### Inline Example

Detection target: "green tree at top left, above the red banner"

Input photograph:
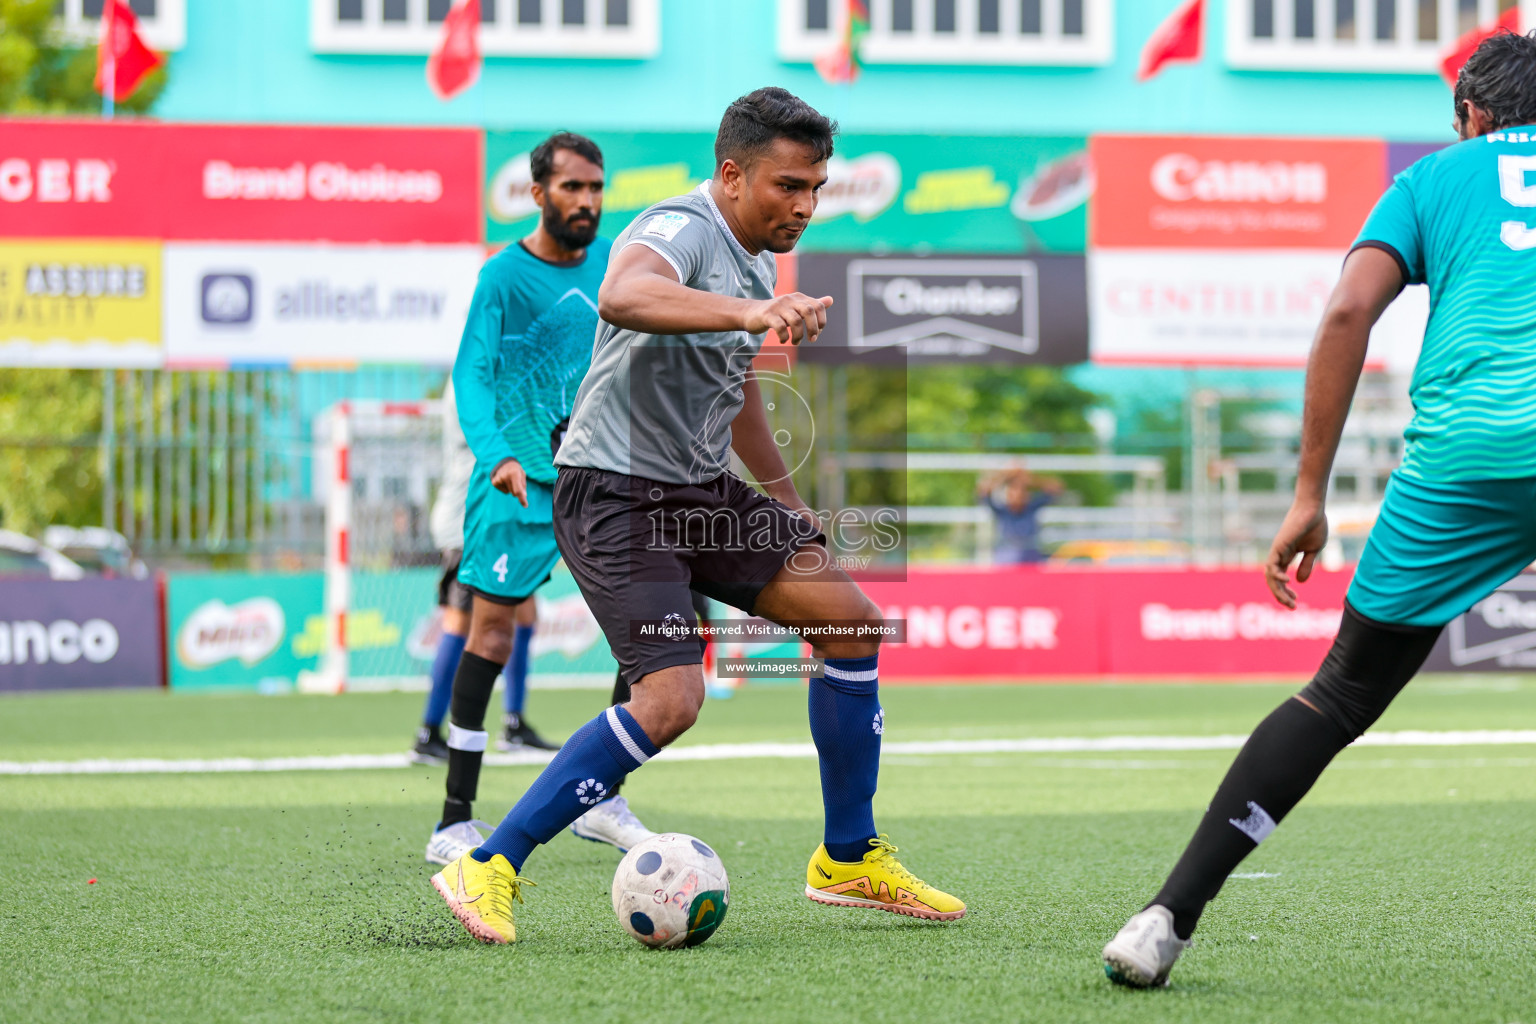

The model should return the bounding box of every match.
[0,0,166,114]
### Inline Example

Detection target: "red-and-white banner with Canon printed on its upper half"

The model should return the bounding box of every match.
[1087,135,1428,363]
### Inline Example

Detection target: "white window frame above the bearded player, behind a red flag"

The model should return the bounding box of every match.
[309,0,662,58]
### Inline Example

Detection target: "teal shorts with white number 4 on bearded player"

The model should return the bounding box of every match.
[459,470,561,605]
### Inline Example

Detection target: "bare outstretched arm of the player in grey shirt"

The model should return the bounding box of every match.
[598,244,833,344]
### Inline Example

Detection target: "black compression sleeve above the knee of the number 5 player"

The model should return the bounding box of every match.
[1301,602,1444,740]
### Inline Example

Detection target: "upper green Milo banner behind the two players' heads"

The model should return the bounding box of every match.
[485,132,1094,253]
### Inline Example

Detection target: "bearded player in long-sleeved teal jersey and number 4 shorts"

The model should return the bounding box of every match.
[427,132,651,864]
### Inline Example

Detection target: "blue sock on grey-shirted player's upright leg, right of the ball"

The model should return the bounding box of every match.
[811,656,885,863]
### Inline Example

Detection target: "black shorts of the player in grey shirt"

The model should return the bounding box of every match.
[554,467,826,683]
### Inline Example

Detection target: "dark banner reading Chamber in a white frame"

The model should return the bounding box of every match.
[797,253,1087,365]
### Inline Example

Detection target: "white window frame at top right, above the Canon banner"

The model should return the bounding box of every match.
[1226,0,1536,75]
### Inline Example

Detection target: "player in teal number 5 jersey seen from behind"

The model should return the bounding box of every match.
[1104,32,1536,987]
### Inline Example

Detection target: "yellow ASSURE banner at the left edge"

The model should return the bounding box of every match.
[0,241,161,367]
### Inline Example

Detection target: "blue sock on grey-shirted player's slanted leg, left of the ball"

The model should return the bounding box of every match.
[473,708,659,870]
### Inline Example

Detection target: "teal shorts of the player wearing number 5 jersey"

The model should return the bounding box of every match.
[1349,473,1536,626]
